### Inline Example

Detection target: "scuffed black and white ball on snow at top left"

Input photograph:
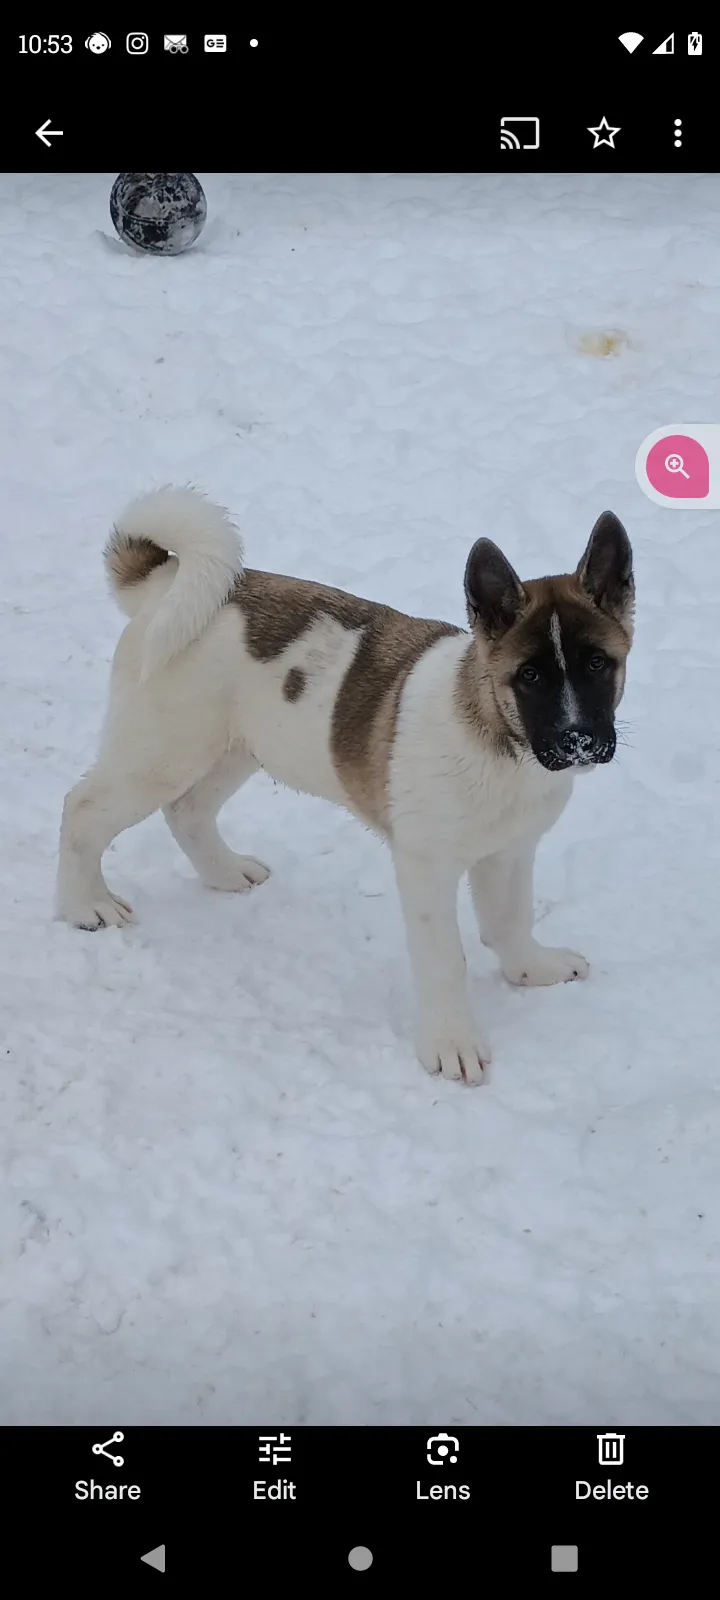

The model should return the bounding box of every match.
[110,173,208,256]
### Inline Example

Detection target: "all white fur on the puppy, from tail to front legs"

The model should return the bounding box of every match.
[58,491,587,1083]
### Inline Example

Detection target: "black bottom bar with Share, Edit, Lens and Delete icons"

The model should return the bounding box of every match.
[5,1419,714,1594]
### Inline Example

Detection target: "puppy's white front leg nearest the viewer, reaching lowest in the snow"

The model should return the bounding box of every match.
[394,850,490,1083]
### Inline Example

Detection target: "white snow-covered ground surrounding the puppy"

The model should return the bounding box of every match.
[0,174,720,1427]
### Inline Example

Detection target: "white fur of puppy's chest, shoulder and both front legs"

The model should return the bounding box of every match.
[382,637,587,1083]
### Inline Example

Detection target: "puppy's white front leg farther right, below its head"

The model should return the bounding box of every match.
[469,840,589,987]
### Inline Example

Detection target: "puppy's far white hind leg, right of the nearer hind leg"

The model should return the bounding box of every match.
[163,744,269,894]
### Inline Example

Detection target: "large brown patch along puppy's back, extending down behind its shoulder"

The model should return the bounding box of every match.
[232,568,462,832]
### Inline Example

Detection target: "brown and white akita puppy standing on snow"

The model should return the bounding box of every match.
[58,488,634,1083]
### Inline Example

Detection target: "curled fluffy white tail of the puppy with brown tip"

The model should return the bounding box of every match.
[104,488,243,678]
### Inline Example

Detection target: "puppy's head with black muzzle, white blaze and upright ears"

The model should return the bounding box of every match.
[466,510,635,771]
